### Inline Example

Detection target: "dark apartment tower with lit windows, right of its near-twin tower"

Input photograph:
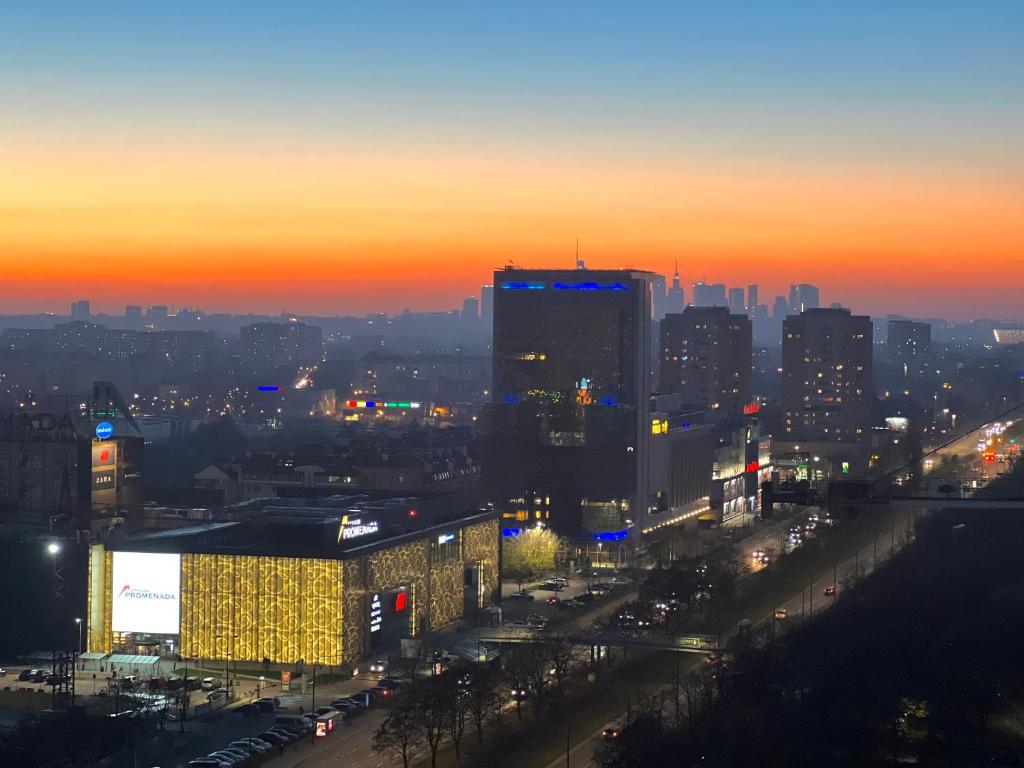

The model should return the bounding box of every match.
[782,309,874,442]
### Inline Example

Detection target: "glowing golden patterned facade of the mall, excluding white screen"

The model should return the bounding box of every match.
[88,519,500,666]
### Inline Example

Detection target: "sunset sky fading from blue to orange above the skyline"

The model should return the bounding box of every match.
[0,0,1024,318]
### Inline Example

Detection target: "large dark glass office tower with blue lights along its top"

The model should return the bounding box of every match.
[483,269,652,546]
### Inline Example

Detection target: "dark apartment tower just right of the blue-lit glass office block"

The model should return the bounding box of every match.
[658,306,753,417]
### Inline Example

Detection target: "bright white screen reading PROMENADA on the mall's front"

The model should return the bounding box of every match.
[111,552,181,635]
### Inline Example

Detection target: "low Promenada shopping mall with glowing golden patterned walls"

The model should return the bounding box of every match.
[88,497,501,665]
